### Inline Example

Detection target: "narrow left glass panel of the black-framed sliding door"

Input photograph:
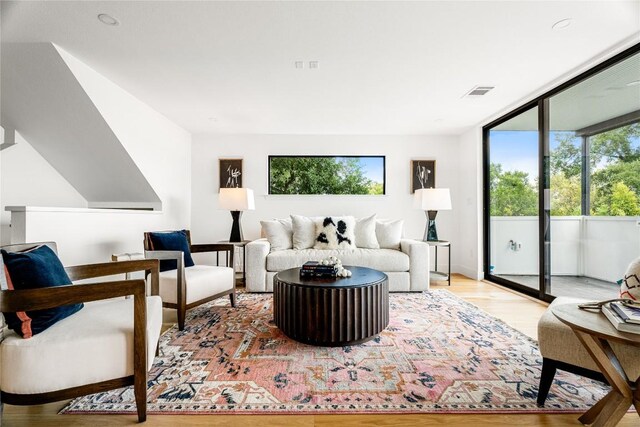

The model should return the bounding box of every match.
[487,107,540,298]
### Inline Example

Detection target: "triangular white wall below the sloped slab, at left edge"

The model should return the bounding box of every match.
[0,134,87,245]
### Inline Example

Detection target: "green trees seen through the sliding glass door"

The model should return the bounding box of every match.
[490,123,640,216]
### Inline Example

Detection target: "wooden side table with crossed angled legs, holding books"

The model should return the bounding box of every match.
[552,304,640,427]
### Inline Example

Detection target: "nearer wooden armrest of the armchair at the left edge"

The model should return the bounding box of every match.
[0,279,146,313]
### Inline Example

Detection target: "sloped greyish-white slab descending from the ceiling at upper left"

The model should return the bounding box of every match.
[0,43,161,208]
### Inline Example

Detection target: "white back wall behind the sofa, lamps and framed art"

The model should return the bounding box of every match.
[191,135,461,268]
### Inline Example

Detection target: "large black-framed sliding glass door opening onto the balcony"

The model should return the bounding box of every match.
[484,45,640,300]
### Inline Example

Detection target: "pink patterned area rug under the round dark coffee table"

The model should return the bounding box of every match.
[61,290,608,414]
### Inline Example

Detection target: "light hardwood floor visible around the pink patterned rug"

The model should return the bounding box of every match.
[2,275,640,427]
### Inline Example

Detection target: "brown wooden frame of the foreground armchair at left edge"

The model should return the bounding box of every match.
[0,242,159,422]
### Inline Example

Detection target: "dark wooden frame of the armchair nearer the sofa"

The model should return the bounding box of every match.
[144,230,236,331]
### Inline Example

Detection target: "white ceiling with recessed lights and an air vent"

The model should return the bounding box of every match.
[1,1,640,134]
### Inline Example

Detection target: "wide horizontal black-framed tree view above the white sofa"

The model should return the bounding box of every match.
[269,156,385,195]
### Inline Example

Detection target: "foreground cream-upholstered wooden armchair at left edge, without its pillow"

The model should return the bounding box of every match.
[0,242,162,422]
